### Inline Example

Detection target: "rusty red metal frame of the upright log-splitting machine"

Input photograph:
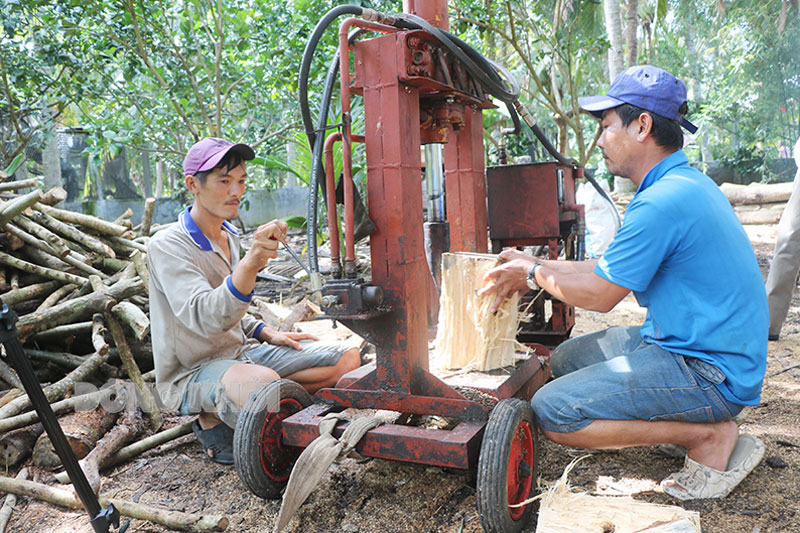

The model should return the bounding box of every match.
[282,0,549,469]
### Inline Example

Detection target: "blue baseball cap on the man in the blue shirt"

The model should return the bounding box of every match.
[578,65,697,133]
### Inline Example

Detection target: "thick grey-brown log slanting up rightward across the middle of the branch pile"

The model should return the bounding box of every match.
[17,278,144,338]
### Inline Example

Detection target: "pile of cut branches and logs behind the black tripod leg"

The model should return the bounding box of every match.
[0,180,227,532]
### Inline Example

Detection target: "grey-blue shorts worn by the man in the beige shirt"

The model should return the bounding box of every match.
[179,341,353,427]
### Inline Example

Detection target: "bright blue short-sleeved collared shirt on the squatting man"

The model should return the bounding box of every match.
[594,151,769,405]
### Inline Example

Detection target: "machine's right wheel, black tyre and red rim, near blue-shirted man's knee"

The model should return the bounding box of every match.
[477,398,539,533]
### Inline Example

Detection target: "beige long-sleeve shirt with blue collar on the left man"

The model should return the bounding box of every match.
[147,208,263,409]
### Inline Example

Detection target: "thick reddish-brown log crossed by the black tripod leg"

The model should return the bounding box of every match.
[33,407,119,470]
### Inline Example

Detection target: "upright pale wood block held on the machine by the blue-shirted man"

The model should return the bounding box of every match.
[431,253,520,370]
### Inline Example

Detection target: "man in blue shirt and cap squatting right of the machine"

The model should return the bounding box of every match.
[481,66,768,500]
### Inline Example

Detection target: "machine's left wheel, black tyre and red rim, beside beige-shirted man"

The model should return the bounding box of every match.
[233,379,312,499]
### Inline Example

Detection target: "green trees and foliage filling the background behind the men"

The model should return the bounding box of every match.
[0,0,800,195]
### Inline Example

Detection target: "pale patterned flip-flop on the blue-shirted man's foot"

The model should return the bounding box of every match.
[661,434,764,500]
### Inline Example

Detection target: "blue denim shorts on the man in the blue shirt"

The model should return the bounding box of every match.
[531,326,743,433]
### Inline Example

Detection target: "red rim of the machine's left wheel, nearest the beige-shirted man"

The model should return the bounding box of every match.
[258,398,303,481]
